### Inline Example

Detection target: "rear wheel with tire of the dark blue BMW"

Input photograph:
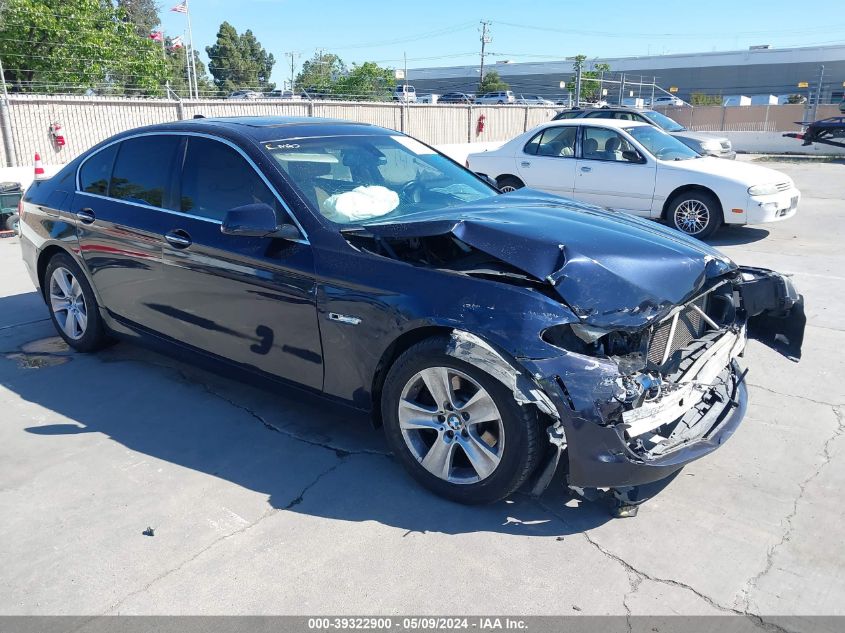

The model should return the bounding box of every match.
[41,253,110,352]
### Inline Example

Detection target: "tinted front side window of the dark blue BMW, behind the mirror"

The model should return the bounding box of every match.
[180,136,279,221]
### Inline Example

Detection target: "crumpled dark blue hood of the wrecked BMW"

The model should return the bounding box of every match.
[365,189,736,328]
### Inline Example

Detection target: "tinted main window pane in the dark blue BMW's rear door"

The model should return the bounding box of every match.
[109,135,180,208]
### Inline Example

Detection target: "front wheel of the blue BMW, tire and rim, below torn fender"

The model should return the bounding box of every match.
[381,337,541,504]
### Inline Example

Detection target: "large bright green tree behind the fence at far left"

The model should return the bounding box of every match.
[0,0,165,95]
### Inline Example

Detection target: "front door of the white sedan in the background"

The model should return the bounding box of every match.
[573,125,657,216]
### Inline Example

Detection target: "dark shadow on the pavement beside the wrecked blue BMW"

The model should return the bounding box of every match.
[0,298,611,537]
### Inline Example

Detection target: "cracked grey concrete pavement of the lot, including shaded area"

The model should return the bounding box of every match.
[0,158,845,616]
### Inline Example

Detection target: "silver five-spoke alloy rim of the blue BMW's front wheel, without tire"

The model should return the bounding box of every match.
[398,367,505,484]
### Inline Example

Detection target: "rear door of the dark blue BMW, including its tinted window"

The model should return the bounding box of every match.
[71,135,180,329]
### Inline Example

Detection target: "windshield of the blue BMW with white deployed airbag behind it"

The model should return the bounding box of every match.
[262,135,498,225]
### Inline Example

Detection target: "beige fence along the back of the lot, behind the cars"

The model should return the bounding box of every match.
[0,95,838,166]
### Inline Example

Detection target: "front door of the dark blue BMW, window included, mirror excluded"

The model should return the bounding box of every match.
[154,135,323,389]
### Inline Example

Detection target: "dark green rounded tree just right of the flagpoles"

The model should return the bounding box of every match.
[205,22,276,95]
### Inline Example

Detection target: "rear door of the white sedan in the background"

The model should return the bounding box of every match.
[516,125,578,197]
